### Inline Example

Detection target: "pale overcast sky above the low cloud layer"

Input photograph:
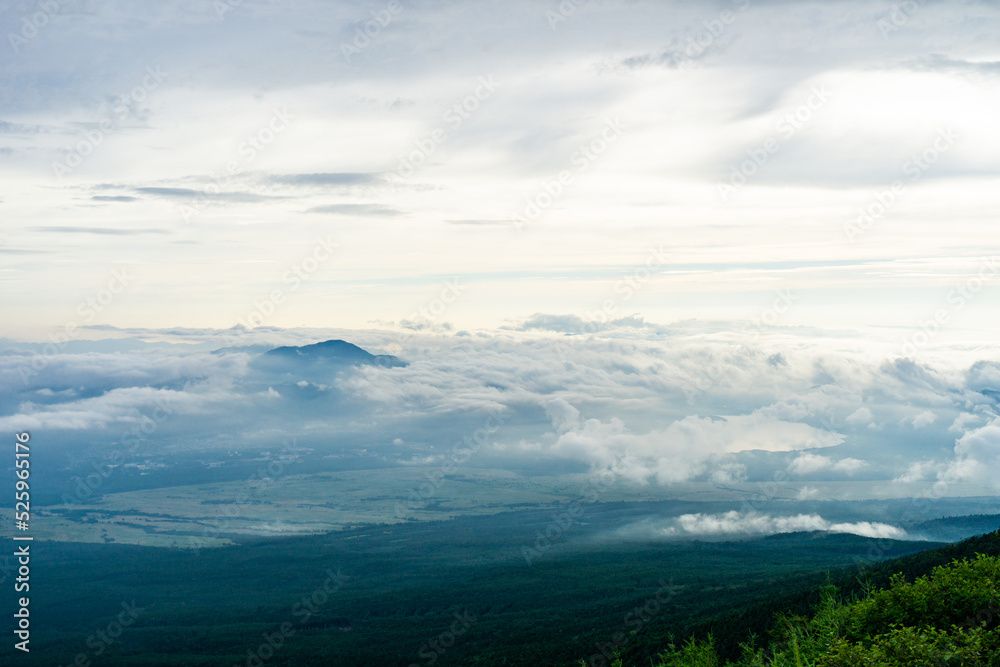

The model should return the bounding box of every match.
[0,0,1000,342]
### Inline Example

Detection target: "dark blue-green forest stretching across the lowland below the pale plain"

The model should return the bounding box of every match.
[0,506,1000,667]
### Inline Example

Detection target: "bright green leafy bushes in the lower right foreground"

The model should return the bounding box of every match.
[659,555,1000,667]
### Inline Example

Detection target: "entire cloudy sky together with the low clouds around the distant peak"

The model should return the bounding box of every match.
[0,0,1000,496]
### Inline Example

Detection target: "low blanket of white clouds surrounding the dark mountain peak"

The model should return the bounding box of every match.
[0,323,1000,497]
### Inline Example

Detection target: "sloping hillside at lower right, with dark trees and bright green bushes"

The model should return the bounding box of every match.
[648,532,1000,667]
